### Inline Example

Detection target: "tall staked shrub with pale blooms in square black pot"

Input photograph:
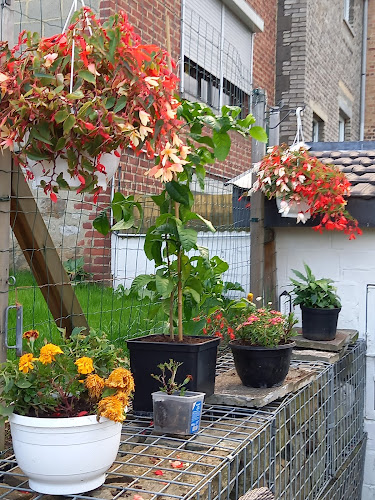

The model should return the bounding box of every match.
[107,101,266,413]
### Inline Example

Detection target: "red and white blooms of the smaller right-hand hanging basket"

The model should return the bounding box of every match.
[251,145,362,239]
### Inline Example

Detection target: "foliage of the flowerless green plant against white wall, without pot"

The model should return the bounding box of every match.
[290,263,341,309]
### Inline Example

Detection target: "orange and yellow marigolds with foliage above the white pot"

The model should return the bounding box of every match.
[0,328,134,422]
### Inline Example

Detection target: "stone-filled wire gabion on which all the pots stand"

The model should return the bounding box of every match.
[0,342,365,500]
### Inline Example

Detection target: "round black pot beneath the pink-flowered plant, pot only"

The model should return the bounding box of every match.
[229,340,295,388]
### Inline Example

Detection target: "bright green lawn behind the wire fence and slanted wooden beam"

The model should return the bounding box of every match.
[9,271,165,343]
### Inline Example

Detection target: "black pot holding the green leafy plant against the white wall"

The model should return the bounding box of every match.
[301,305,341,340]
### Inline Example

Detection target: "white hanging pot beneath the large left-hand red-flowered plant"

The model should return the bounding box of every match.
[27,148,120,189]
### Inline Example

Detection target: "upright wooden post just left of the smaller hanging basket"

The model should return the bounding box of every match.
[250,89,266,297]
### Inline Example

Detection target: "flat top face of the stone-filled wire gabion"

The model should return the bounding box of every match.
[0,405,272,500]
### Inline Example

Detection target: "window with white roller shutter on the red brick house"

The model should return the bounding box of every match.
[181,0,253,114]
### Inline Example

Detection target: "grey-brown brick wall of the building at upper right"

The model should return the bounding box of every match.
[276,0,363,143]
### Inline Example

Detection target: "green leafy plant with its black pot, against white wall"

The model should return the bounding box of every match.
[290,264,341,340]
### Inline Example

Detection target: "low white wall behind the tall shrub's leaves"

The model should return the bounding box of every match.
[112,231,250,293]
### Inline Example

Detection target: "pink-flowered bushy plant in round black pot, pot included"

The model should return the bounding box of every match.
[215,299,297,388]
